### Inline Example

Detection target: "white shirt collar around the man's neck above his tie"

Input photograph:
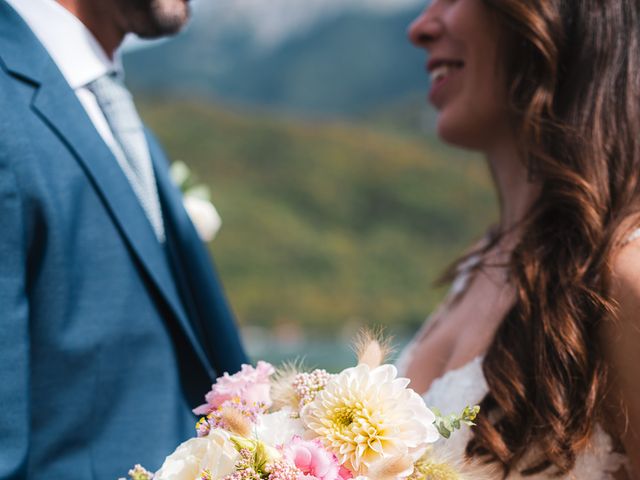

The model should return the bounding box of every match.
[6,0,122,90]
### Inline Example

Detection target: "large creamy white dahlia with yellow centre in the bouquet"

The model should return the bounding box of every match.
[301,364,439,478]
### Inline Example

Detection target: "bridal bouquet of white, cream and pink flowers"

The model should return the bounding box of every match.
[121,338,478,480]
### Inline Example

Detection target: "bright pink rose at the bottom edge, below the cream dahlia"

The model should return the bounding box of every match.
[282,436,351,480]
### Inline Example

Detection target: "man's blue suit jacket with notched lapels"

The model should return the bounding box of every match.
[0,0,245,480]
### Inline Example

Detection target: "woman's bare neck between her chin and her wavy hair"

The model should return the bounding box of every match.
[487,139,540,237]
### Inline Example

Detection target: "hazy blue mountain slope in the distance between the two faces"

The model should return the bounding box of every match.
[125,8,427,116]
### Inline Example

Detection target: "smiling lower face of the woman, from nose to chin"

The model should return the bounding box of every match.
[409,0,510,151]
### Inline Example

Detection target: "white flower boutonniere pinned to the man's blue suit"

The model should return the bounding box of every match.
[170,161,222,243]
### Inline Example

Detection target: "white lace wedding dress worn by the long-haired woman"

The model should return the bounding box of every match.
[396,229,640,480]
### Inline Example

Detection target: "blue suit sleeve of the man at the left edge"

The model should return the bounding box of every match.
[0,158,30,480]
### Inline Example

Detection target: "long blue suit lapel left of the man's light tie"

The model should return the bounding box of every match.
[0,0,214,376]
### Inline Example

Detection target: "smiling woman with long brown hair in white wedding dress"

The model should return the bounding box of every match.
[399,0,640,480]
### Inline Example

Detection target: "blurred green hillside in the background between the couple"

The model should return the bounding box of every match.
[141,102,496,334]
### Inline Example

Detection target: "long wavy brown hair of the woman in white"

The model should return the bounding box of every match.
[450,0,640,475]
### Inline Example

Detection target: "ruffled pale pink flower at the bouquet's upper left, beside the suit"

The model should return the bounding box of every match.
[193,361,275,415]
